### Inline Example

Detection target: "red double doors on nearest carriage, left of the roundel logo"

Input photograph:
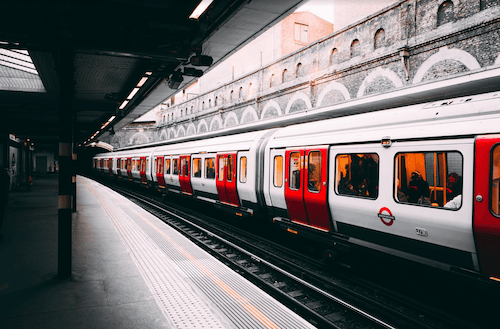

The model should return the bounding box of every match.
[285,146,331,231]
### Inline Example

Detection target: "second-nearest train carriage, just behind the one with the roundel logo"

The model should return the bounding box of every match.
[152,130,274,216]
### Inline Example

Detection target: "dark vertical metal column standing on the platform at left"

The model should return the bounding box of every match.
[57,47,75,278]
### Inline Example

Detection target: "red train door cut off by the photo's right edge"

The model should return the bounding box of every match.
[474,135,500,279]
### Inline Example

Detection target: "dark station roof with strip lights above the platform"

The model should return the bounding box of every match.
[0,0,305,148]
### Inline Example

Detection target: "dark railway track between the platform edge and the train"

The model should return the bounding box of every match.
[97,179,479,329]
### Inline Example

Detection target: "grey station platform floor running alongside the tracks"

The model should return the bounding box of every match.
[0,174,313,328]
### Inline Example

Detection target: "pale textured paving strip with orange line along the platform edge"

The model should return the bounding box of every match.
[79,177,314,329]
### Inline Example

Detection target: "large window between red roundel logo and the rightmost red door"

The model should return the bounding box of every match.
[394,152,463,209]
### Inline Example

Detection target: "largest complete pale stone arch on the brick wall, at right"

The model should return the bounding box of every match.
[413,47,481,84]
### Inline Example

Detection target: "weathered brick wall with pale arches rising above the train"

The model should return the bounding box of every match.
[103,0,500,145]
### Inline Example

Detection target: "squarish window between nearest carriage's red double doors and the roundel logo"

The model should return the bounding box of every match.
[335,153,379,199]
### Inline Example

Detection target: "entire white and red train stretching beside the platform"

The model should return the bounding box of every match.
[93,92,500,284]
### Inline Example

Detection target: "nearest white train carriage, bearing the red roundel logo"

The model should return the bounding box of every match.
[264,94,500,276]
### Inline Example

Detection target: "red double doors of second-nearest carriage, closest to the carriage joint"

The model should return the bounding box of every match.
[216,152,240,206]
